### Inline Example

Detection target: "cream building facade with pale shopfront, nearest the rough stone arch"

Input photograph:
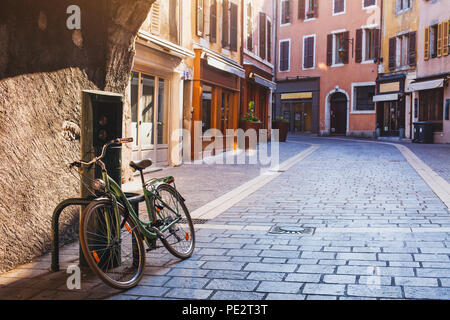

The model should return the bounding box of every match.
[128,0,194,167]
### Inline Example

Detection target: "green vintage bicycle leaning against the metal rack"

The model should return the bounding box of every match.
[69,138,195,289]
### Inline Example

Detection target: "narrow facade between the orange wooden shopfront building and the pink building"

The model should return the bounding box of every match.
[244,0,276,136]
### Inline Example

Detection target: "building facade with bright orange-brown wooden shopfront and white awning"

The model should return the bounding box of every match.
[183,0,245,159]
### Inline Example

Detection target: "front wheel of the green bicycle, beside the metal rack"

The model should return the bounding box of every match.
[80,199,145,290]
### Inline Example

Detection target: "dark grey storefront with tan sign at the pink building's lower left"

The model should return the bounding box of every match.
[274,78,320,134]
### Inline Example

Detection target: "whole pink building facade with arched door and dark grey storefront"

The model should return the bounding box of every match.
[275,0,381,137]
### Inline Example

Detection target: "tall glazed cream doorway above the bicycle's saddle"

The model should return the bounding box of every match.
[131,72,168,165]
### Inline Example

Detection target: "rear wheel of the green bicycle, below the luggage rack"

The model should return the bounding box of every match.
[152,184,195,259]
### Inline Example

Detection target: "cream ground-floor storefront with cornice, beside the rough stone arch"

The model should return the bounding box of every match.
[129,33,194,168]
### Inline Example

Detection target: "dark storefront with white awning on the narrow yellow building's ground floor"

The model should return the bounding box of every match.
[373,74,406,138]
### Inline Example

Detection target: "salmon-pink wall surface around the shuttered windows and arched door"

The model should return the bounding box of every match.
[276,0,381,133]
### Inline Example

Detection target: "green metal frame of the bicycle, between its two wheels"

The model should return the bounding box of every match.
[102,168,181,247]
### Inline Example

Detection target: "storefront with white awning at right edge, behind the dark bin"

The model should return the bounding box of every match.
[409,74,450,143]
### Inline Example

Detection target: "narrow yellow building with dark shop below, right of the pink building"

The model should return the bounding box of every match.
[374,0,420,139]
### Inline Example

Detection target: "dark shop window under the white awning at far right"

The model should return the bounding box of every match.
[419,88,444,132]
